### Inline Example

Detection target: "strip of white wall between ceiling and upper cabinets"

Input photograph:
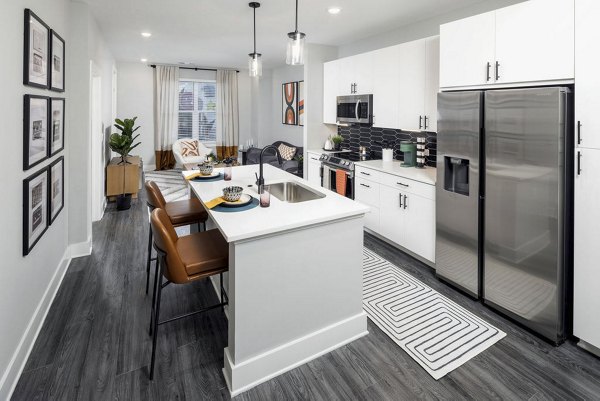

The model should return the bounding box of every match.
[338,0,524,58]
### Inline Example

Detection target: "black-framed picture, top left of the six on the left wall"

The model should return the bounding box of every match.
[23,8,50,88]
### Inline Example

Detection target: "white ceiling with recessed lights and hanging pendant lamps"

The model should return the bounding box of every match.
[85,0,483,68]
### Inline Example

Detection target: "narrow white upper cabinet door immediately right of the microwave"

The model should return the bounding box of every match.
[372,46,400,128]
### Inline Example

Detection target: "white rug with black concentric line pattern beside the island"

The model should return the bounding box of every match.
[363,248,506,380]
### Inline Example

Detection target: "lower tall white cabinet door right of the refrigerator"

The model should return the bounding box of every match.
[573,146,600,348]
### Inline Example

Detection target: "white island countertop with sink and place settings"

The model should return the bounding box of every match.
[182,164,369,242]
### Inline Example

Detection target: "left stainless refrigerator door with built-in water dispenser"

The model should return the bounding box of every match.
[435,92,483,297]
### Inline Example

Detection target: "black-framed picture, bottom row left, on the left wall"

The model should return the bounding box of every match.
[23,168,48,256]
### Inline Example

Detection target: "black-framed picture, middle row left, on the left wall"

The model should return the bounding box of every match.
[23,95,49,170]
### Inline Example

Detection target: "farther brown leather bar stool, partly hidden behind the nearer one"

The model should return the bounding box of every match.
[145,181,208,294]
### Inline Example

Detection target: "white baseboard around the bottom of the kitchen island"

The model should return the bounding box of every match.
[223,312,369,397]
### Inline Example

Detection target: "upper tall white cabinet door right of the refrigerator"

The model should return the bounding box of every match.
[575,0,600,149]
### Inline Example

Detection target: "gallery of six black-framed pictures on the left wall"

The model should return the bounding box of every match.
[23,9,65,256]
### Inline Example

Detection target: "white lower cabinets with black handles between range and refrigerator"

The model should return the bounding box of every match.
[355,167,435,262]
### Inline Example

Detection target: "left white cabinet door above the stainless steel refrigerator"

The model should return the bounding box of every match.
[440,11,496,87]
